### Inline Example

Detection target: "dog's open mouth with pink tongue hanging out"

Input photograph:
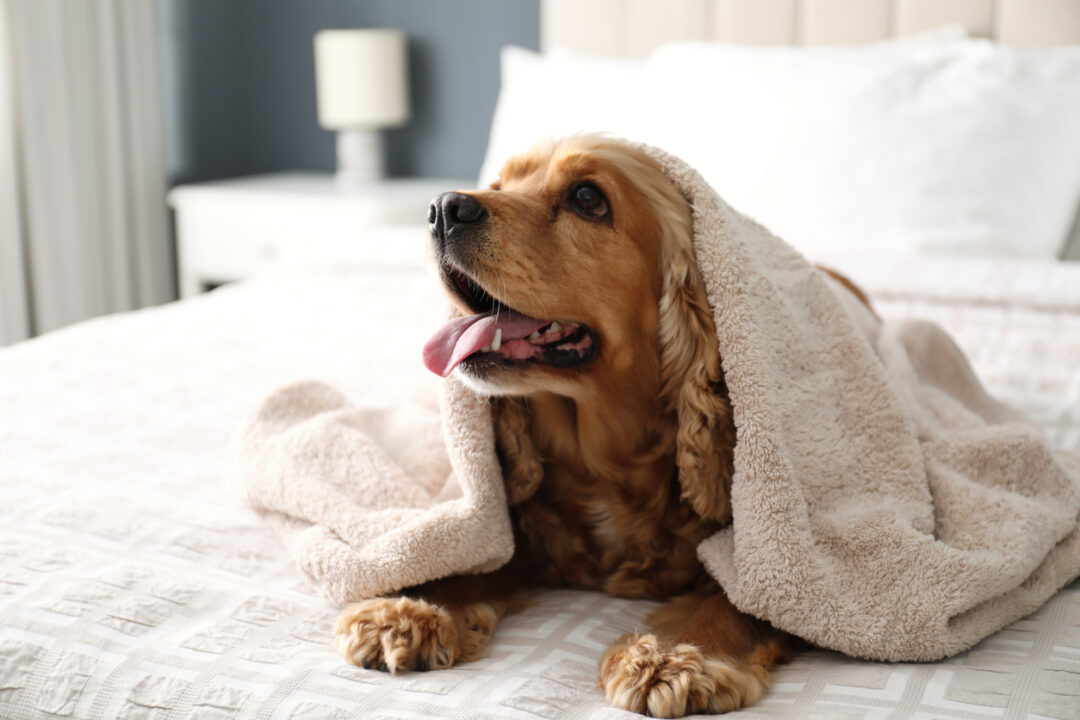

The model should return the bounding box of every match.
[423,266,597,378]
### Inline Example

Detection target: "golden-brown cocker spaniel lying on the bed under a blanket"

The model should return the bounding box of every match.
[335,136,865,718]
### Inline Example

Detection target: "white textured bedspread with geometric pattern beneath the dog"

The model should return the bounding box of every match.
[0,258,1080,720]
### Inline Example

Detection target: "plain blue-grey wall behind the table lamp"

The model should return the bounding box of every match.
[156,0,540,185]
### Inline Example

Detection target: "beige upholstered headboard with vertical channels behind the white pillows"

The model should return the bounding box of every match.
[541,0,1080,55]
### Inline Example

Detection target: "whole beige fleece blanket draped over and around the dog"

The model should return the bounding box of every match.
[229,143,1080,661]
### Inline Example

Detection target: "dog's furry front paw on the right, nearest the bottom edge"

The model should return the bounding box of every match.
[599,635,766,718]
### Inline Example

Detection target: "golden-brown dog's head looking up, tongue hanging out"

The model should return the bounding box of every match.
[426,136,715,405]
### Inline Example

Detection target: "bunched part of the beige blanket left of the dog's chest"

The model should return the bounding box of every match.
[226,381,513,604]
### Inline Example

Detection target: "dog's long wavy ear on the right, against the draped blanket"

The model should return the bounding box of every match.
[659,199,734,521]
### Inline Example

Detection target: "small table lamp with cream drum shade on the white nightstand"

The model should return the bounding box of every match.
[315,29,409,185]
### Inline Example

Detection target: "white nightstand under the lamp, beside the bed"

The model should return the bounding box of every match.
[168,173,475,298]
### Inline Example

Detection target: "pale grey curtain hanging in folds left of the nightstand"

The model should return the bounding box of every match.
[0,0,174,342]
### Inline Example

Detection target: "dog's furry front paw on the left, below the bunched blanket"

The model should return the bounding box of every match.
[334,598,459,673]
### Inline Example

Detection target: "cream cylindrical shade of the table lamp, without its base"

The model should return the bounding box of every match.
[315,29,409,130]
